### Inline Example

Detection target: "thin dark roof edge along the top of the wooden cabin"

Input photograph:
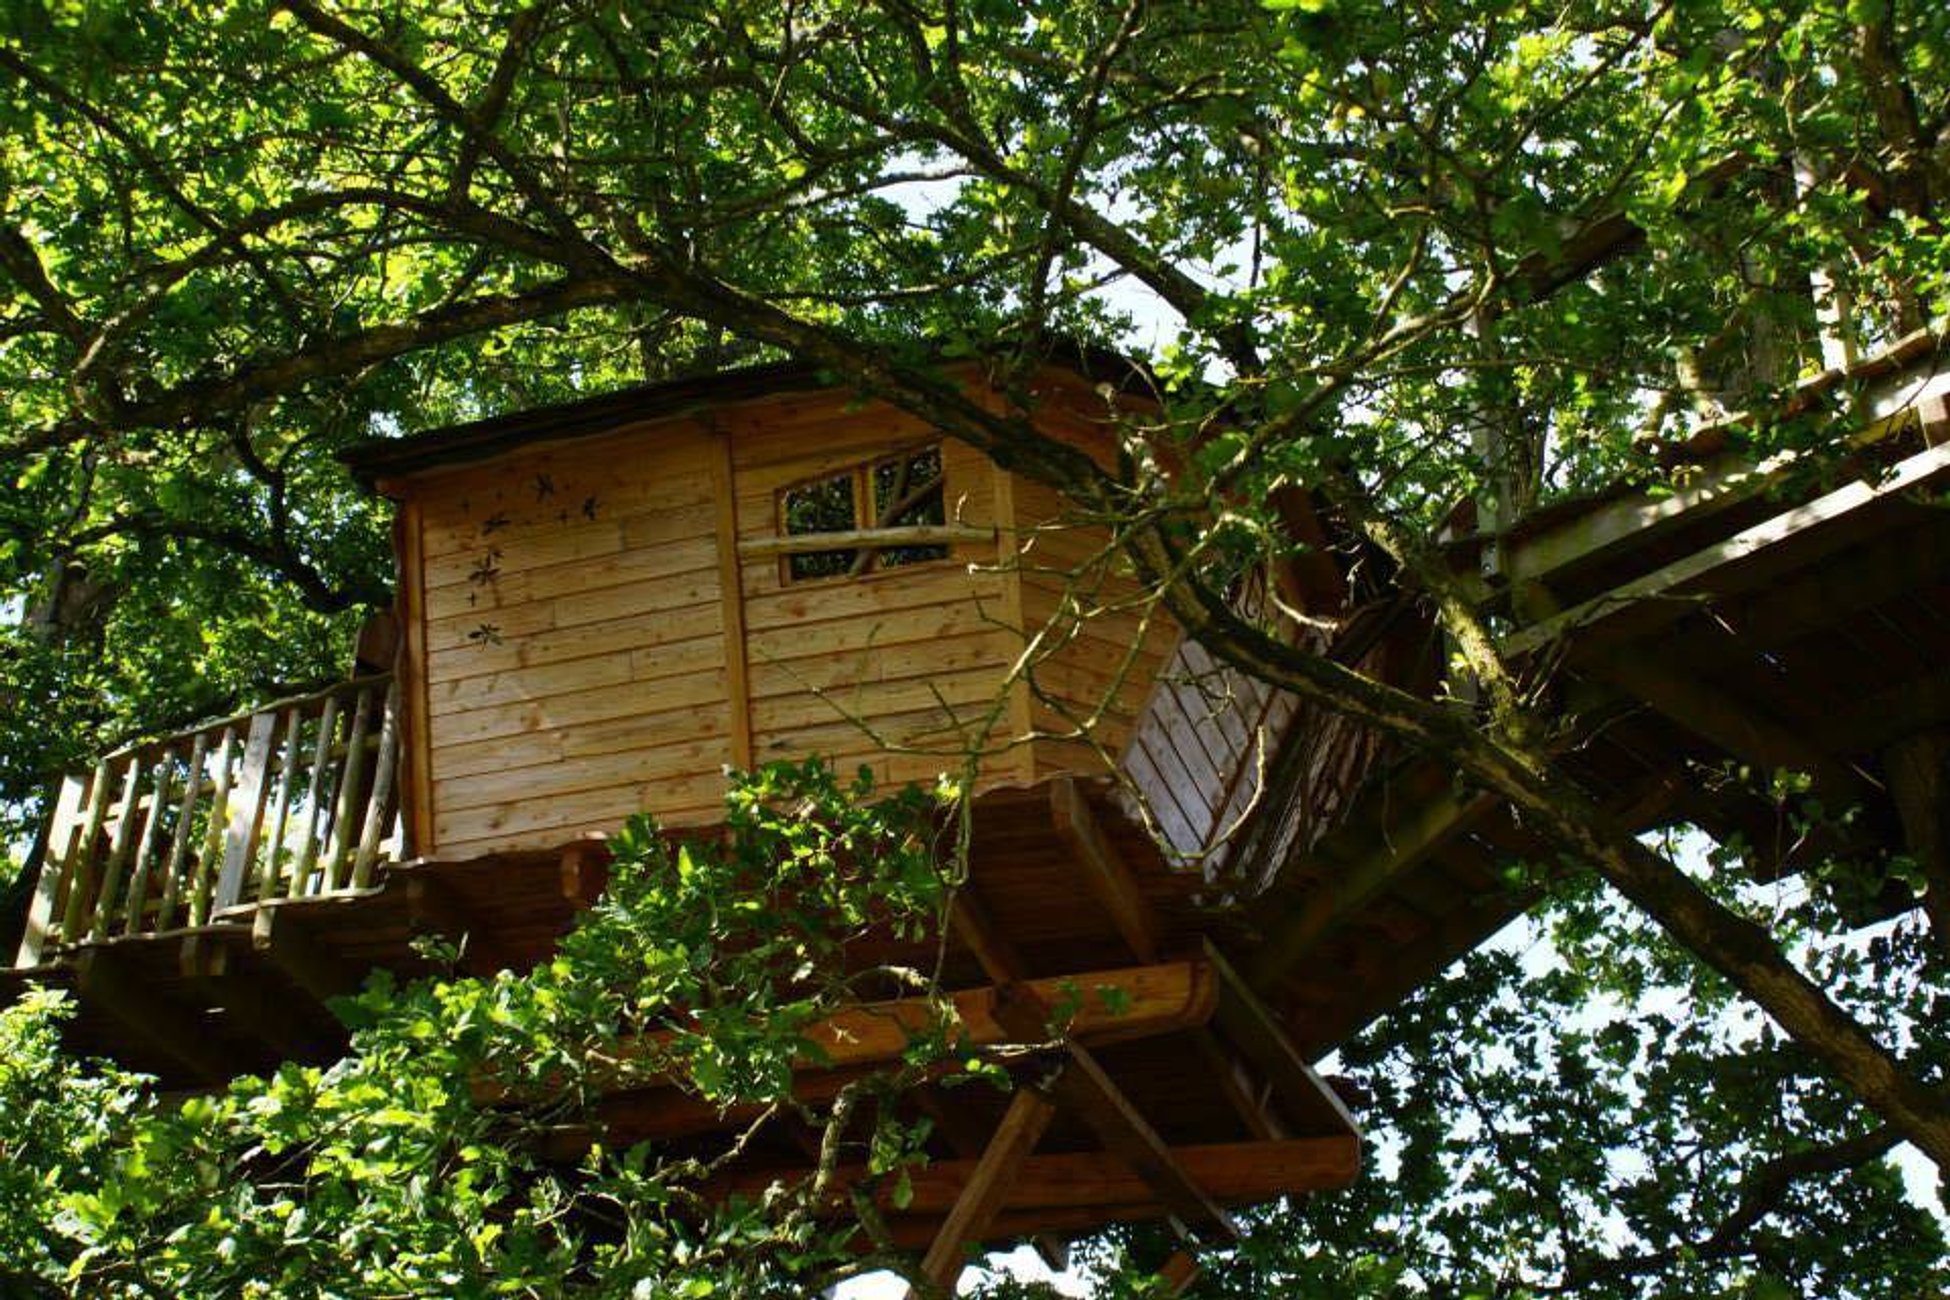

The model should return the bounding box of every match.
[339,341,1151,489]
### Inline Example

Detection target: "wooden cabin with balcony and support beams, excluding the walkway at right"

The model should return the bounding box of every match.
[3,352,1357,1281]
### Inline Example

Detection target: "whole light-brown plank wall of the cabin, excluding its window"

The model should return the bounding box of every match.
[402,374,1193,858]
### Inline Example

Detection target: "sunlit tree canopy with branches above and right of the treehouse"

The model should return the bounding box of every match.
[0,0,1950,1296]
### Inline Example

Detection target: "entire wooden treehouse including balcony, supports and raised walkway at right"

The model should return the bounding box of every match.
[12,335,1950,1281]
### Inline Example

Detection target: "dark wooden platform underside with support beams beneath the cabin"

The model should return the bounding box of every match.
[8,780,1359,1267]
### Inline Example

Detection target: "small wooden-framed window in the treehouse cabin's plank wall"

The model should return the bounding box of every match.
[778,446,948,583]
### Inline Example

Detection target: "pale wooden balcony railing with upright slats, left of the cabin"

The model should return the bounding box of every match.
[16,676,400,967]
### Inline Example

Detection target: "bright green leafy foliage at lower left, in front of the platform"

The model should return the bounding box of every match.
[0,764,982,1298]
